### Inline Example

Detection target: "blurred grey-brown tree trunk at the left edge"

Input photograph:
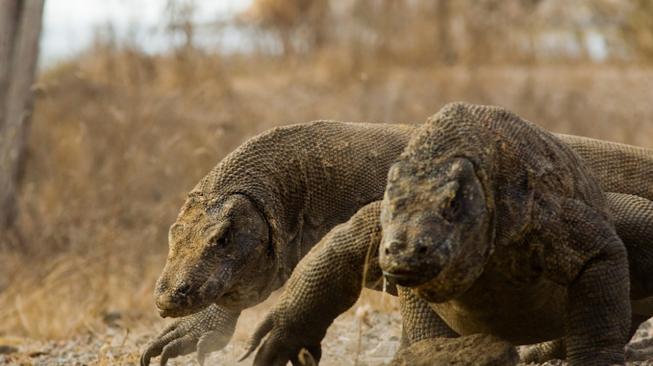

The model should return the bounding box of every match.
[0,0,44,241]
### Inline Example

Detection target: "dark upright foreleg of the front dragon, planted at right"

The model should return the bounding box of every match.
[543,200,631,366]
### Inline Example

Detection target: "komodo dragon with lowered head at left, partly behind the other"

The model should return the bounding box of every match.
[141,121,653,365]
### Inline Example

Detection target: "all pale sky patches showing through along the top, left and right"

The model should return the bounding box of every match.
[40,0,607,67]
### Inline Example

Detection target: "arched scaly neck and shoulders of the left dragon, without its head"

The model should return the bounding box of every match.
[189,121,413,286]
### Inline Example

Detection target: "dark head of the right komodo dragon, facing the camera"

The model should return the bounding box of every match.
[379,157,494,302]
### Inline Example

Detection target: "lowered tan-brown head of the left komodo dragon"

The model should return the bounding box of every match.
[154,194,273,317]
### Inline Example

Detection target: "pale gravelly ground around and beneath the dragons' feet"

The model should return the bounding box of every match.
[0,304,653,366]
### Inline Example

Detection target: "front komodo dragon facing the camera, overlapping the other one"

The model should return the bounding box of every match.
[243,104,653,365]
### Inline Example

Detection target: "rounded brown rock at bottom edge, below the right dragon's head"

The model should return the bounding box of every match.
[390,334,519,366]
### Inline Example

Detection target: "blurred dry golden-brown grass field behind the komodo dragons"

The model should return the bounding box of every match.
[0,43,653,339]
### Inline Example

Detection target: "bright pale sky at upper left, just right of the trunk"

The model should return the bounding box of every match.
[39,0,251,65]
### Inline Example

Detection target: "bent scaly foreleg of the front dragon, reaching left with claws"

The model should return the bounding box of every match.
[238,201,382,366]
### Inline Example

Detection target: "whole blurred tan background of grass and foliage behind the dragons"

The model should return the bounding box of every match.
[0,0,653,338]
